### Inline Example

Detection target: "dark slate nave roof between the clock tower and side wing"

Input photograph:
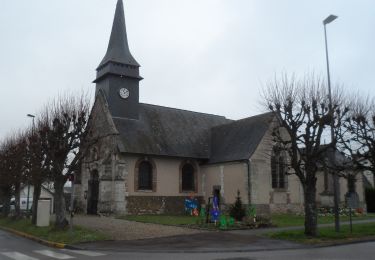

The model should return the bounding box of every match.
[113,104,231,159]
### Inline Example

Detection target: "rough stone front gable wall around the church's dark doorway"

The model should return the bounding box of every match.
[76,94,127,214]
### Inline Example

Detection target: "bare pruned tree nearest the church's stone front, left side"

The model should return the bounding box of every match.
[40,95,90,228]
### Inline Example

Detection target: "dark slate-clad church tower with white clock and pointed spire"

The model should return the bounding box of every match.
[94,0,142,119]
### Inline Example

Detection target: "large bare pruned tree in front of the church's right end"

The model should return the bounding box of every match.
[263,75,347,236]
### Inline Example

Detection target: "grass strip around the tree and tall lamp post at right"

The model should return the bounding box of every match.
[267,223,375,244]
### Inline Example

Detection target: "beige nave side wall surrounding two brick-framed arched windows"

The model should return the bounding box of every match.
[122,155,203,214]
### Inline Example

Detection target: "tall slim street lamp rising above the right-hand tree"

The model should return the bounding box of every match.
[323,14,340,232]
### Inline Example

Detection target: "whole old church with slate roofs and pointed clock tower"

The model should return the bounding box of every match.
[75,0,363,214]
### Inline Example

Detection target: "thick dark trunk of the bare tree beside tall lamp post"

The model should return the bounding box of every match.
[304,182,318,237]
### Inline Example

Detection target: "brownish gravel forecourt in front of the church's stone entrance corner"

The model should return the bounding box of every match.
[74,215,202,240]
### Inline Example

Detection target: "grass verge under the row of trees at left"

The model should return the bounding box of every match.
[0,218,109,244]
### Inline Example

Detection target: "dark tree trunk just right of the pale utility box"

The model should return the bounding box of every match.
[54,178,68,229]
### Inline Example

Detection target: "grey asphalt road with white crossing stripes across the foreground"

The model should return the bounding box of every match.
[0,231,375,260]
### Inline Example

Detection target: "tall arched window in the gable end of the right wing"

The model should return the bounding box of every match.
[271,147,287,189]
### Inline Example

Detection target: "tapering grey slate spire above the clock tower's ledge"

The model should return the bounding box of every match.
[98,0,140,68]
